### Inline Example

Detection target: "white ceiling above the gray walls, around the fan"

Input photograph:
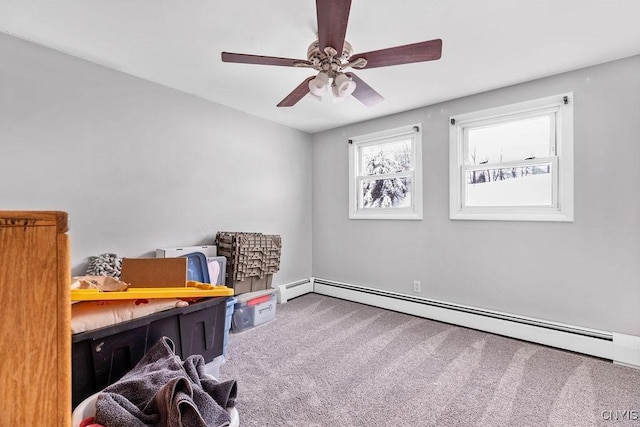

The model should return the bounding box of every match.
[0,0,640,133]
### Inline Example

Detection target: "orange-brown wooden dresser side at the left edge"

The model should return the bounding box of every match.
[0,211,71,427]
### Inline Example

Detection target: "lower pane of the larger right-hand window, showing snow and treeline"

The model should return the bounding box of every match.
[465,163,553,206]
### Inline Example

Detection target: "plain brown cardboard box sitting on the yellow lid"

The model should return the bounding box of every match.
[120,257,188,288]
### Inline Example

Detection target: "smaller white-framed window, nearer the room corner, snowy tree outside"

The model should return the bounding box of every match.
[349,125,422,219]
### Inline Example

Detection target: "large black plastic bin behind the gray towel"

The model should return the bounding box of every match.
[71,298,227,408]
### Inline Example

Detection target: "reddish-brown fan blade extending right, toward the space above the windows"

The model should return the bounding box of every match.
[349,39,442,69]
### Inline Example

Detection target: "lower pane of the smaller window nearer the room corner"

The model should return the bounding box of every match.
[360,177,411,208]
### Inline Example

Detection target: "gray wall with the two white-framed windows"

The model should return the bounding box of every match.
[313,56,640,335]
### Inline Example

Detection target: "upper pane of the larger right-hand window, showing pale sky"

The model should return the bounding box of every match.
[467,115,552,165]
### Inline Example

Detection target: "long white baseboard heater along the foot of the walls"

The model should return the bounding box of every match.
[302,277,640,367]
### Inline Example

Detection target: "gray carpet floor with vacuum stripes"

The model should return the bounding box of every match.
[220,294,640,427]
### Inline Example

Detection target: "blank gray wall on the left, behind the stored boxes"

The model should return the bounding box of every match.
[0,34,311,284]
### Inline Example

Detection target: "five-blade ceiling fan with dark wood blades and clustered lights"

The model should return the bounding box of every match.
[222,0,442,107]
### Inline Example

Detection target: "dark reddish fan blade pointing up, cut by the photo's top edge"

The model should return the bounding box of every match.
[316,0,351,56]
